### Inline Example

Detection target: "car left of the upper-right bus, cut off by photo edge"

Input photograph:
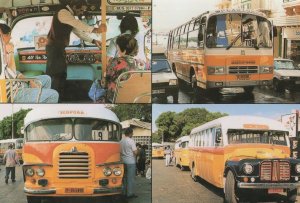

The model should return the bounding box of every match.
[151,54,179,103]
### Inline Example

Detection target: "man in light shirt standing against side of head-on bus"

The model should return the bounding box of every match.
[120,127,137,198]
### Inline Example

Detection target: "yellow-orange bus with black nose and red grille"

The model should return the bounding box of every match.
[189,116,300,203]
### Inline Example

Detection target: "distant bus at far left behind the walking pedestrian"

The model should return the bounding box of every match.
[0,138,24,164]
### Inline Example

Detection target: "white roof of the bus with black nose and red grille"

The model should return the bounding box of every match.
[191,116,288,134]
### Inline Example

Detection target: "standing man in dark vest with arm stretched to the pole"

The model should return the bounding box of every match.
[46,0,107,100]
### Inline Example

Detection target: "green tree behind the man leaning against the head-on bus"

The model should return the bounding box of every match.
[110,104,152,122]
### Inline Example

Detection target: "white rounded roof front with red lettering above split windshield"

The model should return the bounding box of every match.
[24,104,120,128]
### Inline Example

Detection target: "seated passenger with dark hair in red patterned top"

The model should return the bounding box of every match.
[104,34,145,102]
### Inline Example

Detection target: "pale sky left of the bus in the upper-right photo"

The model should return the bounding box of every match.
[152,0,221,33]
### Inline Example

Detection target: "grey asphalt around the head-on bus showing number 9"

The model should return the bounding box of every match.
[0,165,151,203]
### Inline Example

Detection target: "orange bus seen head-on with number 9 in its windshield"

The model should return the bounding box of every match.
[23,105,124,203]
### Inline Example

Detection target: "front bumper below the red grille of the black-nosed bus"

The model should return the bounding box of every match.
[237,182,300,189]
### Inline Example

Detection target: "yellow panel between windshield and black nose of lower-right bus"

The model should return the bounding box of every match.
[225,144,290,161]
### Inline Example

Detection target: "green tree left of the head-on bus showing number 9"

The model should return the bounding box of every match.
[0,109,31,139]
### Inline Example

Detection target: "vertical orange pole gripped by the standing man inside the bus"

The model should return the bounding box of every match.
[100,0,107,79]
